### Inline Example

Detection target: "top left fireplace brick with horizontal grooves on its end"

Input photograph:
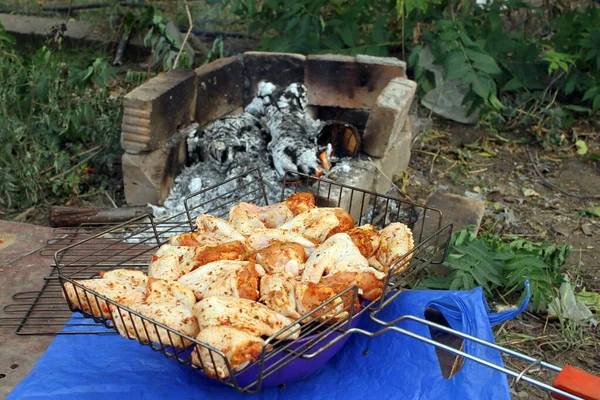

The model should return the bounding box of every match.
[121,69,196,154]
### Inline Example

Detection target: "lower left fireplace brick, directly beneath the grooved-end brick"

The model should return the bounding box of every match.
[122,137,186,205]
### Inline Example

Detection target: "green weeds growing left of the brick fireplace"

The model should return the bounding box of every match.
[0,25,121,208]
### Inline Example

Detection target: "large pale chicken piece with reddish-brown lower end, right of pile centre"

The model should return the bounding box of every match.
[302,233,386,300]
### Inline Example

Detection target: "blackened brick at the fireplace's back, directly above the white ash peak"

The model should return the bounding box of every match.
[243,51,306,103]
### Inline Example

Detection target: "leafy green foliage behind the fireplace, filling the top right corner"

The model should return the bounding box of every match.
[204,0,600,146]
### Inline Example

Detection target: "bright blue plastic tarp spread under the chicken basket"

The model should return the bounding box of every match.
[8,288,528,400]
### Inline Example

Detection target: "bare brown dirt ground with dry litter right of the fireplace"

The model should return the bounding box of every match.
[408,121,600,399]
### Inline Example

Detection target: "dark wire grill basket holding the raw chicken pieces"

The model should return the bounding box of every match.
[55,170,452,393]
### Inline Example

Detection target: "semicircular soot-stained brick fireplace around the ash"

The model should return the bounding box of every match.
[121,52,416,205]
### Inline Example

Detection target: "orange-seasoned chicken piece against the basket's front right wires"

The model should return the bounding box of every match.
[260,274,348,323]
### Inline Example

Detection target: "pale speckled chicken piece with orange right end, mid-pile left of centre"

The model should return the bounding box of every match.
[178,260,265,301]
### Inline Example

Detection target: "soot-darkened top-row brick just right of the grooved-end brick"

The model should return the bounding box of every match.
[196,57,244,126]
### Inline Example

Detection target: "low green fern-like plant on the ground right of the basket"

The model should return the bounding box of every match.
[419,229,572,310]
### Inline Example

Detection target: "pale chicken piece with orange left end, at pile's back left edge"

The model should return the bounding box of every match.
[169,214,246,246]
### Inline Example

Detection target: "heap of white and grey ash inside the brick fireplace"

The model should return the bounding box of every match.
[151,82,324,219]
